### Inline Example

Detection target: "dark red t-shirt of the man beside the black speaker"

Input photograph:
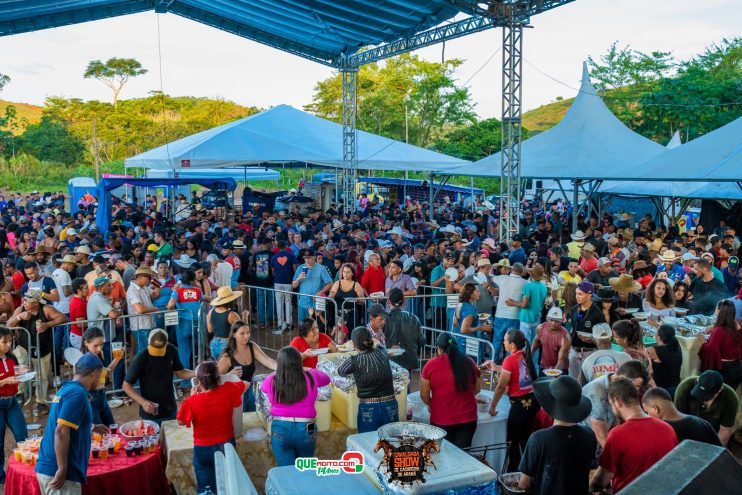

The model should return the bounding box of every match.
[600,417,678,493]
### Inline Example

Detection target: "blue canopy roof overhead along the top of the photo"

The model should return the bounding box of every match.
[0,0,459,64]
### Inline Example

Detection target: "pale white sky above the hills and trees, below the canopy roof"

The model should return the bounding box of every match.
[0,0,742,118]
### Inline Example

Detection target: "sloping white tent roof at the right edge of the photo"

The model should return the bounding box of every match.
[636,117,742,182]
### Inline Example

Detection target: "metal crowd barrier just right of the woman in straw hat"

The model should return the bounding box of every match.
[238,285,342,352]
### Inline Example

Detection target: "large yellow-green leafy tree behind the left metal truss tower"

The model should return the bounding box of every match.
[304,54,476,146]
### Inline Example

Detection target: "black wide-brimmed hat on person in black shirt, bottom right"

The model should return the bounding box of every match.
[533,375,593,423]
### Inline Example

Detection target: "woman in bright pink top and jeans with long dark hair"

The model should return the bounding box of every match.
[260,346,330,466]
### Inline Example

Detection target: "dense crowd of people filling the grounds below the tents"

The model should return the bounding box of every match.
[0,188,742,494]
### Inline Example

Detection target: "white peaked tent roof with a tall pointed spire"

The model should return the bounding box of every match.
[442,64,665,180]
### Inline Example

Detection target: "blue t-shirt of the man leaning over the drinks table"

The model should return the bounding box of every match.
[36,381,93,483]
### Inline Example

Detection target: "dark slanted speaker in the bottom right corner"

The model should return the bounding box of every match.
[621,440,742,495]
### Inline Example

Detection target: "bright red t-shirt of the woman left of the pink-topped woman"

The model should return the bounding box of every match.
[177,382,245,447]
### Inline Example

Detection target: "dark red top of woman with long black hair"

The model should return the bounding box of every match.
[422,354,480,425]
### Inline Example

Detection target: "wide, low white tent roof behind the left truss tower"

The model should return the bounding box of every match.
[126,105,471,172]
